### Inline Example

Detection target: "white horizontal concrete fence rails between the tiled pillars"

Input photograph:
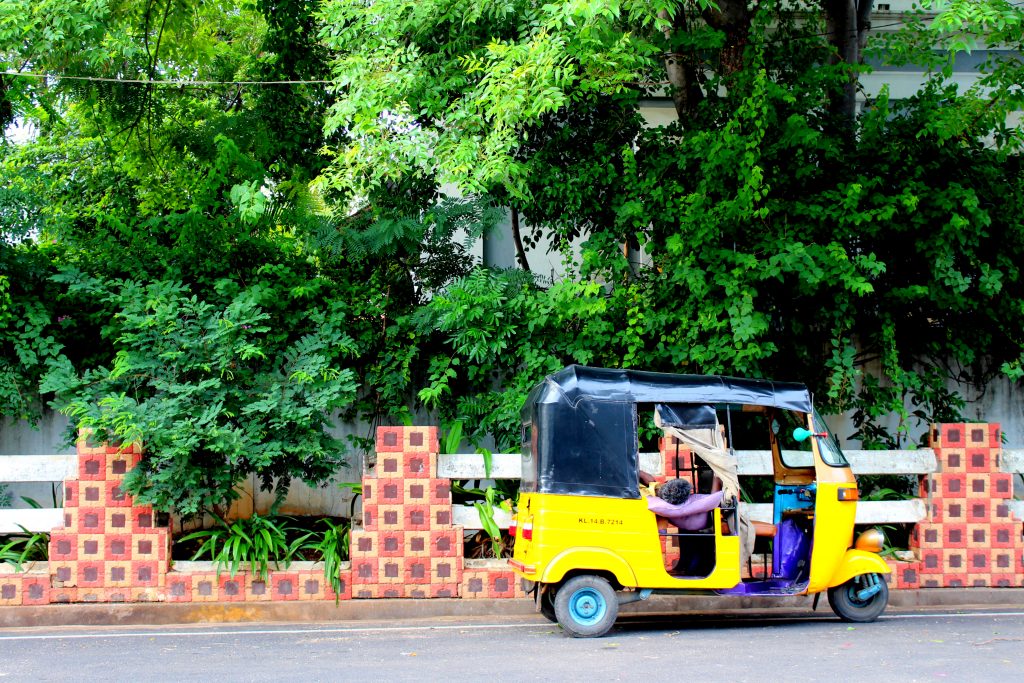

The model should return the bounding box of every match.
[0,449,1024,533]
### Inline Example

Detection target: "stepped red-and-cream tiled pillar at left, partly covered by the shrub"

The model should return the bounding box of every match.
[49,432,170,602]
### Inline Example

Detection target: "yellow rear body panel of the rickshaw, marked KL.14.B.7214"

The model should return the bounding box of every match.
[513,494,739,590]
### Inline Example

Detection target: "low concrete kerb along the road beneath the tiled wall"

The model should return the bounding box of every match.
[0,588,1024,628]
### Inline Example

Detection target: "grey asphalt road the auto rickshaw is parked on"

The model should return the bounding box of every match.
[0,607,1024,683]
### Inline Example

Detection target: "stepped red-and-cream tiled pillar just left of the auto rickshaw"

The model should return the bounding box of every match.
[349,427,463,598]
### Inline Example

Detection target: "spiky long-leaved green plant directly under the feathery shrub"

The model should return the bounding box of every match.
[178,513,309,582]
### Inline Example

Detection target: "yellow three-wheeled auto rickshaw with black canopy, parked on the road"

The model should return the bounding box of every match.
[510,366,890,637]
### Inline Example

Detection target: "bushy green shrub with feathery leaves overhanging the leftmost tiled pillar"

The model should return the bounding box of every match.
[43,274,356,516]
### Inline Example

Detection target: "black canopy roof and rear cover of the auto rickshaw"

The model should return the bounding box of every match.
[522,366,812,498]
